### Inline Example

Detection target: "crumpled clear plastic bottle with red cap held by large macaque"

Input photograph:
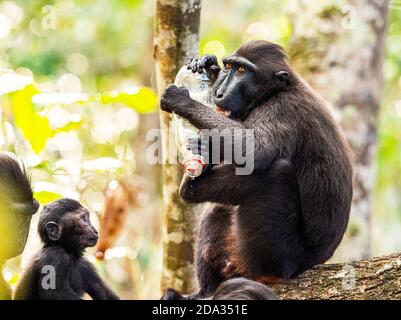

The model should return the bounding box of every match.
[173,66,213,178]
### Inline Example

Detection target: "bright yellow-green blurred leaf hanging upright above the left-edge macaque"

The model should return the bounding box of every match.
[11,85,54,153]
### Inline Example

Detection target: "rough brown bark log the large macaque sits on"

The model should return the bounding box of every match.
[269,253,401,300]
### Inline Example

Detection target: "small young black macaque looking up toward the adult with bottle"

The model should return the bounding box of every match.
[14,199,119,300]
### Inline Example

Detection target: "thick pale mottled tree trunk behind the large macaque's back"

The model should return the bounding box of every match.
[290,0,389,261]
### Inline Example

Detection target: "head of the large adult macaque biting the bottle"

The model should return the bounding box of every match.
[213,42,291,120]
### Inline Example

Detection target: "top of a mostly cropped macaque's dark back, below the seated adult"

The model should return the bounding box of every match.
[162,278,280,300]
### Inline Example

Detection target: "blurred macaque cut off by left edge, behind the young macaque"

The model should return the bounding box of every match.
[0,152,39,300]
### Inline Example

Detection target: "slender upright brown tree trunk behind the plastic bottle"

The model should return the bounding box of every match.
[154,0,201,293]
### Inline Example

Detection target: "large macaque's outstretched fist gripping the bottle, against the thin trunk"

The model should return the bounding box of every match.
[160,84,193,113]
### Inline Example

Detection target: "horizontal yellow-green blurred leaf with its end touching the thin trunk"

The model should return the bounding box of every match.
[100,87,157,113]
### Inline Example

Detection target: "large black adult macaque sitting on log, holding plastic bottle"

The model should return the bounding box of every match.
[160,41,352,297]
